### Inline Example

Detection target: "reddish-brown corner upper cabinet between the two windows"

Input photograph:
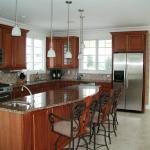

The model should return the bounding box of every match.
[46,36,79,68]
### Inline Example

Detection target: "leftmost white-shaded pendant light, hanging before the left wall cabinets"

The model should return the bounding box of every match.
[11,0,21,36]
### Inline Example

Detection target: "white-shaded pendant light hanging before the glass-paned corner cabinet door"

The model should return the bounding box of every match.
[65,1,72,59]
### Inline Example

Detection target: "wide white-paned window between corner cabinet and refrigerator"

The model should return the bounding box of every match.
[79,40,112,74]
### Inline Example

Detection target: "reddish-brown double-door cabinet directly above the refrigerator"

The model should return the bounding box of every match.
[111,31,147,52]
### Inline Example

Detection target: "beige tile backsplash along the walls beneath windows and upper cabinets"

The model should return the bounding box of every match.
[0,69,111,84]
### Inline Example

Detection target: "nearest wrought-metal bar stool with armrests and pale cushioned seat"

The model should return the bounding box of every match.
[49,102,85,150]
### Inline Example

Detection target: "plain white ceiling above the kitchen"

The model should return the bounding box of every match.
[0,0,150,31]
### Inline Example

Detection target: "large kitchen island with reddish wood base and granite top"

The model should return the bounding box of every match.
[0,84,101,150]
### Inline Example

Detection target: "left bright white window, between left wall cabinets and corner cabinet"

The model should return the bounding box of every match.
[26,38,45,71]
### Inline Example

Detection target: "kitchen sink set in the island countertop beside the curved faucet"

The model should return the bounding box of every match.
[2,101,31,109]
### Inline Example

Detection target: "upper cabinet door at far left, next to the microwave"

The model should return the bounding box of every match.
[0,28,12,69]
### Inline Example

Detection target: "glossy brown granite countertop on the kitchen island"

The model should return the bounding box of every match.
[0,84,99,114]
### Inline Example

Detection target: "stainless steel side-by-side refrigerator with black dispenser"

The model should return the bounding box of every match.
[113,53,144,111]
